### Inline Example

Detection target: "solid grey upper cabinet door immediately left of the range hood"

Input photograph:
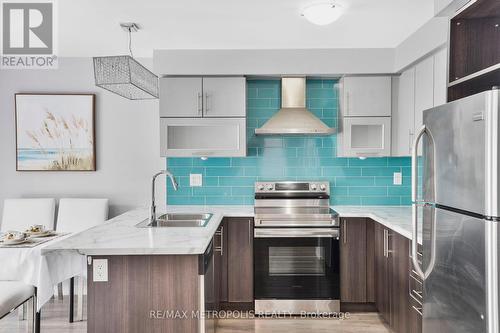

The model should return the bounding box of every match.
[203,77,246,117]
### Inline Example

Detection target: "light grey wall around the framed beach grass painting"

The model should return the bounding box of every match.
[0,58,165,218]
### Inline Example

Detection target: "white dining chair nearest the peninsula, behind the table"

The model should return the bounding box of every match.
[56,198,109,323]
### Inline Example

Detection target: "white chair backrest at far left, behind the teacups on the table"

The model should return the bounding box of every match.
[0,198,56,232]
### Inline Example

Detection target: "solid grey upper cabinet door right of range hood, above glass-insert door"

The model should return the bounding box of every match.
[341,76,391,117]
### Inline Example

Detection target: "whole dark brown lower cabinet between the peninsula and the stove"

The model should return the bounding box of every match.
[218,217,254,310]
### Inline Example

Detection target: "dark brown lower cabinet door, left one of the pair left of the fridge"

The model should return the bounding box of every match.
[374,223,391,323]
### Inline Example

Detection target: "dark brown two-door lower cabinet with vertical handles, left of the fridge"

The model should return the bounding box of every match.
[374,223,421,333]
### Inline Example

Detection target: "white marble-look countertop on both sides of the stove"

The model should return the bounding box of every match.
[44,202,418,255]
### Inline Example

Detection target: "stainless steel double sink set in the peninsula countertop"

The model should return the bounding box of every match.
[136,213,213,228]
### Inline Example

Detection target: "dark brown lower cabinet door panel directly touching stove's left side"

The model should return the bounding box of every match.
[226,218,253,303]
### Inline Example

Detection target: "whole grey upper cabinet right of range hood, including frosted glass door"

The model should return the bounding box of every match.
[337,76,392,157]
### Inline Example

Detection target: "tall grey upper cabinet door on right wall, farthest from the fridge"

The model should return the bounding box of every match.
[392,67,415,156]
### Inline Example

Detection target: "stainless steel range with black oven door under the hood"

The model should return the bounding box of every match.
[254,182,340,314]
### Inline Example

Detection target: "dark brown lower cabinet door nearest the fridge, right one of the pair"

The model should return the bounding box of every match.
[389,232,410,332]
